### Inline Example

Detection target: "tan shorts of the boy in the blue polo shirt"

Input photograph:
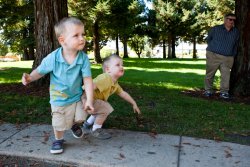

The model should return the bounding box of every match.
[51,101,88,131]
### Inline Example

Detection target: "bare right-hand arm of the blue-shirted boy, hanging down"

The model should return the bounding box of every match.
[83,77,94,112]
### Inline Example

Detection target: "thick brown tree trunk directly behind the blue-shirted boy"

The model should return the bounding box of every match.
[32,0,68,85]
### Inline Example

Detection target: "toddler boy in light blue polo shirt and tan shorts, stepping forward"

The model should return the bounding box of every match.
[22,17,93,154]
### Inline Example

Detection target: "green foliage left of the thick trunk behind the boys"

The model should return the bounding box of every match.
[0,0,35,54]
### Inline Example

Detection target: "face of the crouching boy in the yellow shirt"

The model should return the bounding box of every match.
[106,58,124,78]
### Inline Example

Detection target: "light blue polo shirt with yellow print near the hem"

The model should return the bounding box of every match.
[37,48,91,106]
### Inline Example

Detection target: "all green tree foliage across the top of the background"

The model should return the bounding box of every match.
[0,0,235,61]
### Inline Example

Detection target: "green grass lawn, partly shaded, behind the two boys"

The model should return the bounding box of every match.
[0,59,250,145]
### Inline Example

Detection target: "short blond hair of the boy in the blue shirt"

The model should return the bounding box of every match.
[54,17,84,38]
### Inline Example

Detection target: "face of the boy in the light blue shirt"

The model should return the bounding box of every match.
[59,24,85,51]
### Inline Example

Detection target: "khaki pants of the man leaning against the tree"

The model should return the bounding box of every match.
[205,51,234,93]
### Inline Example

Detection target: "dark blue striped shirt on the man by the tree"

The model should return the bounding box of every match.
[207,24,239,56]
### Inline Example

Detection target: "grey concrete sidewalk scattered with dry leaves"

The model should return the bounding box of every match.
[0,124,250,167]
